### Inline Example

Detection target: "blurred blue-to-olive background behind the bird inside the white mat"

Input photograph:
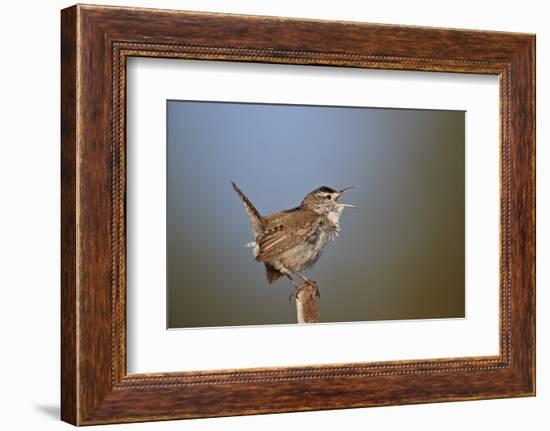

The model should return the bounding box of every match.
[166,101,465,328]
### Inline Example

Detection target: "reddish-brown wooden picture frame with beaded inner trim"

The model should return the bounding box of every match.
[61,5,535,425]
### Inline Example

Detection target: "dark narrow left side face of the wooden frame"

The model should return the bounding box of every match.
[60,6,79,425]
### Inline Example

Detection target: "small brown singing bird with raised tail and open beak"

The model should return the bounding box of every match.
[231,181,356,298]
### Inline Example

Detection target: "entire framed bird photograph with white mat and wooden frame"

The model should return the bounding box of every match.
[61,5,535,425]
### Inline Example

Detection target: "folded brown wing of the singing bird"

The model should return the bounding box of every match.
[256,211,321,262]
